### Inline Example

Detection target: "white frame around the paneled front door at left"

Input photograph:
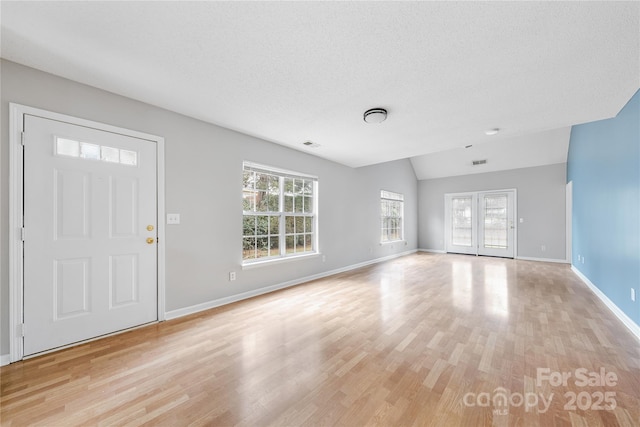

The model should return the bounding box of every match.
[9,103,165,363]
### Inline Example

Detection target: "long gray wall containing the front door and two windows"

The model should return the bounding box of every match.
[0,61,418,354]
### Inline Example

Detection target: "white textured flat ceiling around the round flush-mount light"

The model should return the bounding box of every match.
[0,1,640,179]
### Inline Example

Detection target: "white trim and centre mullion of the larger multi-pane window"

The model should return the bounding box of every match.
[240,161,320,270]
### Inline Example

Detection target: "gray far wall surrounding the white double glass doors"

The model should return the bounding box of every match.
[418,163,566,260]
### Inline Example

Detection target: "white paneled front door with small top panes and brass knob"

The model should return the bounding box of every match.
[23,114,158,356]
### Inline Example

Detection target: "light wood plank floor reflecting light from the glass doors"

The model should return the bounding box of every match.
[0,253,640,426]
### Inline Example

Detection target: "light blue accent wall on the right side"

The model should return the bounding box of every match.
[567,90,640,325]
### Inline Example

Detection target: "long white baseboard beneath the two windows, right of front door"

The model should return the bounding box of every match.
[165,250,417,320]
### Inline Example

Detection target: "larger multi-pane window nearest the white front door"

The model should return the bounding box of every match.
[242,162,318,263]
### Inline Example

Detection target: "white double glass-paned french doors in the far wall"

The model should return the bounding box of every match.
[445,190,516,258]
